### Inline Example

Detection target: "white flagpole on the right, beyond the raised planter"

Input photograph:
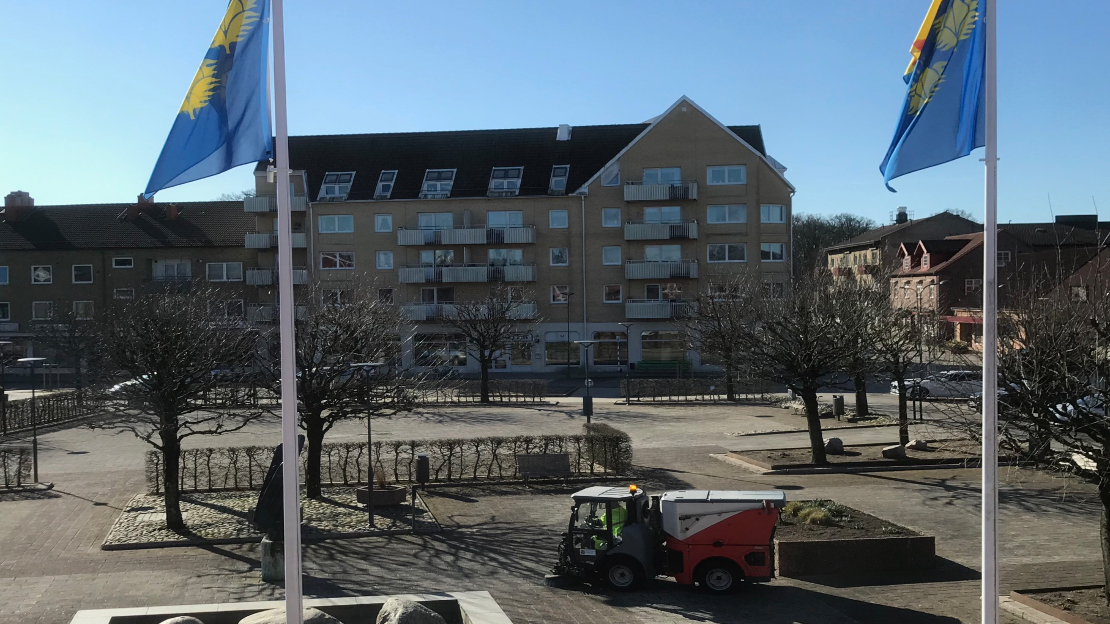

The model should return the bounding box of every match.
[981,1,999,624]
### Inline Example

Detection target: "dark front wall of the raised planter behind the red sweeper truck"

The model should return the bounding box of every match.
[775,535,937,576]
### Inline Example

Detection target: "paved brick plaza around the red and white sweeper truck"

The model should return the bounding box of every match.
[0,395,1101,624]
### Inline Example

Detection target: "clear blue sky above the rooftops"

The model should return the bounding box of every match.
[0,0,1110,222]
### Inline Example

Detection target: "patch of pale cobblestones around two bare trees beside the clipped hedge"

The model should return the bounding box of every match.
[102,487,440,550]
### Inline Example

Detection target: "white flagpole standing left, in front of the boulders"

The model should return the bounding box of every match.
[273,0,304,624]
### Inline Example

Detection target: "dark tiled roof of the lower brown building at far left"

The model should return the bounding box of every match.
[0,201,254,251]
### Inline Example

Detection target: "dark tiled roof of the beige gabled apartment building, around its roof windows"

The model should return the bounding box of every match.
[259,123,766,201]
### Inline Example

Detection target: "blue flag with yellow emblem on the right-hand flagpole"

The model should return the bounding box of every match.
[879,0,989,191]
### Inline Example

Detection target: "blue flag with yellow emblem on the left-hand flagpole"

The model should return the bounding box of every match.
[144,0,273,199]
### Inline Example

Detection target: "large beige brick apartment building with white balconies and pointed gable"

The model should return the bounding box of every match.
[243,98,794,373]
